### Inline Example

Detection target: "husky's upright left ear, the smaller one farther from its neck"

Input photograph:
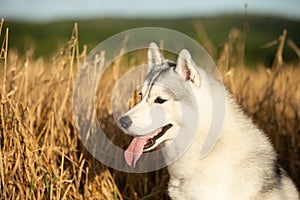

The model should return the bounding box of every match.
[148,42,164,72]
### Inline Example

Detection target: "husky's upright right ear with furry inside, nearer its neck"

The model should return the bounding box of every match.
[175,49,201,87]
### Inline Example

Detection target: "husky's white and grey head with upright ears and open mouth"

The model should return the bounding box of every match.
[119,43,201,167]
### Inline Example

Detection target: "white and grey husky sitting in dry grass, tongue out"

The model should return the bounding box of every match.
[119,43,299,200]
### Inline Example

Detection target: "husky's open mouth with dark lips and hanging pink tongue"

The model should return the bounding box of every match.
[124,124,172,167]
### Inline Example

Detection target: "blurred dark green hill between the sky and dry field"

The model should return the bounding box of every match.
[5,16,300,63]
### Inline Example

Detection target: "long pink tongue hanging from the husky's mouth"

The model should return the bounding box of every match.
[125,137,147,167]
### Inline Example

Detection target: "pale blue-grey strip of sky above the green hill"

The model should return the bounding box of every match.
[0,0,300,22]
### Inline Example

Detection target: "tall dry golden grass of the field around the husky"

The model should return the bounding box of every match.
[0,19,300,200]
